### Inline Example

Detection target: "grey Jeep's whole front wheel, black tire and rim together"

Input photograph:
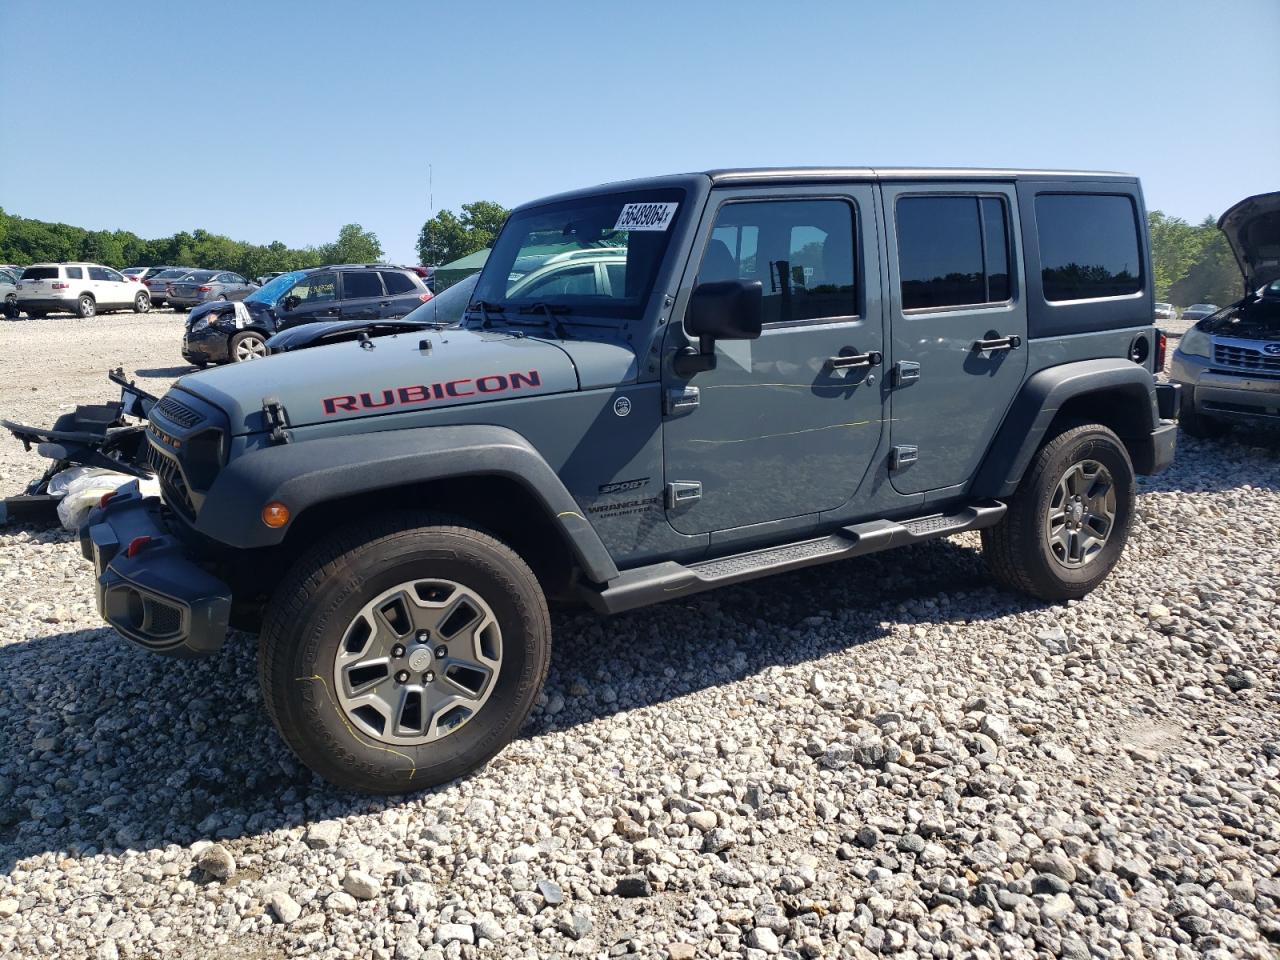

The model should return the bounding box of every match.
[259,511,550,794]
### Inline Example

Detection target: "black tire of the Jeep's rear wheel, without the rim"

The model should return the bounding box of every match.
[982,424,1135,600]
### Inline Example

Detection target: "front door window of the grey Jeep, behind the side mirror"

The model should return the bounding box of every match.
[698,200,858,323]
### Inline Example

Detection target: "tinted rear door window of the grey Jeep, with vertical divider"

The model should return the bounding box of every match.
[896,196,1010,310]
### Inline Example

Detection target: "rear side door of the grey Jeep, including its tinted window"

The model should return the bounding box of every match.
[883,183,1027,493]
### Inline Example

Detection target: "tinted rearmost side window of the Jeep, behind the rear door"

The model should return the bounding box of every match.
[1036,193,1142,301]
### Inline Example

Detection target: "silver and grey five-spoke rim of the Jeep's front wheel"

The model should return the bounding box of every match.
[333,579,502,746]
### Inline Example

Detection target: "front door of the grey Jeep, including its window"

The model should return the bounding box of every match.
[663,184,884,534]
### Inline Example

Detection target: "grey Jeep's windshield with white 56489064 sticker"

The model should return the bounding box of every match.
[467,188,685,326]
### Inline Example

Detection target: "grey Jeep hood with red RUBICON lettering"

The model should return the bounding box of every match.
[177,329,579,434]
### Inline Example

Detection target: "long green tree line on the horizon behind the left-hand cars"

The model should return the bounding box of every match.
[0,209,383,276]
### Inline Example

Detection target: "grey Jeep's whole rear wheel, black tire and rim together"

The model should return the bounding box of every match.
[982,424,1134,600]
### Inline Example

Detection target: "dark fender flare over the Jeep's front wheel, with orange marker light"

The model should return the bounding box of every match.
[195,425,618,584]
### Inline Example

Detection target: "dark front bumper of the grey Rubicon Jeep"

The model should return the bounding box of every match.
[79,483,232,658]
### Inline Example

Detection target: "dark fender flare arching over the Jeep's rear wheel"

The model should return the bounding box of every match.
[970,357,1160,499]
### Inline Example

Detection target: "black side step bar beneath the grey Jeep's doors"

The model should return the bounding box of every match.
[580,500,1006,613]
